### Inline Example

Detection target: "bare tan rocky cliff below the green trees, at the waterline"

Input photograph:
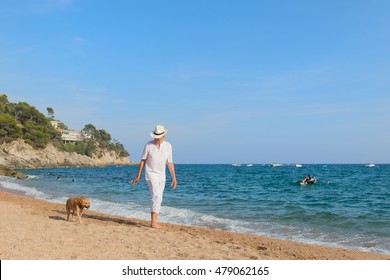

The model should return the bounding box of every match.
[0,140,131,168]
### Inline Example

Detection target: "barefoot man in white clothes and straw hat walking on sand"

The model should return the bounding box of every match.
[130,125,177,228]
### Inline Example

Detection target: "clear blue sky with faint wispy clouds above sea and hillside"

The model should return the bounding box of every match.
[0,0,390,163]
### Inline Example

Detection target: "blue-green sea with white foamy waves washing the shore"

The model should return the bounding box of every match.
[0,164,390,254]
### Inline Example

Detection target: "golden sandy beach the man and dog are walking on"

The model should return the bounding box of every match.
[0,191,390,260]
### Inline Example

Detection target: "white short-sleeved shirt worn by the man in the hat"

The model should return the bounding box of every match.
[142,140,173,181]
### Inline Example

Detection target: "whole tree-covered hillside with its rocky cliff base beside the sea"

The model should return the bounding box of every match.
[0,94,130,168]
